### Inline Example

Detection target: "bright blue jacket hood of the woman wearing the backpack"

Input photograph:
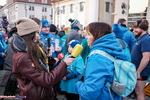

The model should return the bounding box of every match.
[92,33,128,60]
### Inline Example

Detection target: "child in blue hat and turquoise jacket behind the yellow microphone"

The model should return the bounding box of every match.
[60,40,84,100]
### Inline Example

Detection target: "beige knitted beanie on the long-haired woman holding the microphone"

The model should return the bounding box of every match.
[16,18,39,36]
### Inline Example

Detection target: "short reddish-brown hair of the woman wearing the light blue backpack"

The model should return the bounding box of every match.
[86,22,112,41]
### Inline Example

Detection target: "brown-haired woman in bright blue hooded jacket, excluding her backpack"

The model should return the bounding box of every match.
[76,22,127,100]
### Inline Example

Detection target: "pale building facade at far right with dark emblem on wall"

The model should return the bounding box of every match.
[113,0,150,31]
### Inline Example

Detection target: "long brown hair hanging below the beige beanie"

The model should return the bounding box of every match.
[22,32,43,71]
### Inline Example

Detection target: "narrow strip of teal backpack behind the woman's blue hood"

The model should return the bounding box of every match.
[116,37,131,62]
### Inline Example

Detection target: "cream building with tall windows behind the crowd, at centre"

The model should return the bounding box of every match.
[51,0,114,27]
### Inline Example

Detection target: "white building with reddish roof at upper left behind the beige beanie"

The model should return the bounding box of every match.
[2,0,51,24]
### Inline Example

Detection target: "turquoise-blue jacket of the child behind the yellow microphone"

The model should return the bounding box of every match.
[60,54,84,94]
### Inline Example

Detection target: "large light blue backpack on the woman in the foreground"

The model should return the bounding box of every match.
[88,50,137,100]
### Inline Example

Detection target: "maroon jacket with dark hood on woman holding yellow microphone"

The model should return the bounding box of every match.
[12,37,68,100]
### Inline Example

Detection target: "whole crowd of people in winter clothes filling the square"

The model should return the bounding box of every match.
[0,16,150,100]
